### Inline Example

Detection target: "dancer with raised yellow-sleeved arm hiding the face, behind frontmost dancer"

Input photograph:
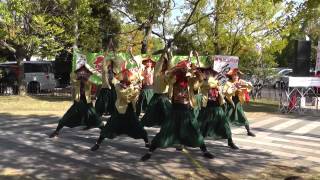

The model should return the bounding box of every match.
[141,52,172,127]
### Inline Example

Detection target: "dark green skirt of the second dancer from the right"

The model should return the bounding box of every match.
[198,101,231,139]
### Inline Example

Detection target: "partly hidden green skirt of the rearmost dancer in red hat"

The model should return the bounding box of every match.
[136,86,154,117]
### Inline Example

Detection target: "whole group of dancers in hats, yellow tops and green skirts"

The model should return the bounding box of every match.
[49,50,255,161]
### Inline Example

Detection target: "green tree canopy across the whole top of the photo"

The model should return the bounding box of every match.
[0,0,320,71]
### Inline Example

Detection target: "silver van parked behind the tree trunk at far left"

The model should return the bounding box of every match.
[0,61,56,93]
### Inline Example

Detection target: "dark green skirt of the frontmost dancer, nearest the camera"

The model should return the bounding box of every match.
[151,104,204,148]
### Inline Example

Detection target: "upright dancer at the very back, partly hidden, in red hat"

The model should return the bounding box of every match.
[137,58,156,117]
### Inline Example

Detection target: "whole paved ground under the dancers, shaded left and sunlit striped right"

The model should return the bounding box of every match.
[0,114,320,179]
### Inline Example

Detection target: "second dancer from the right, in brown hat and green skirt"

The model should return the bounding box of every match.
[198,67,239,149]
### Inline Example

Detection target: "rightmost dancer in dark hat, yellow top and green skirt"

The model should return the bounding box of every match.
[223,68,255,136]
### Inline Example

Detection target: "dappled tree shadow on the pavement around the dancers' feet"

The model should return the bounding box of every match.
[0,113,316,179]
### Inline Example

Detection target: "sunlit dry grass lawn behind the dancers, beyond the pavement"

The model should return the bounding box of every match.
[0,96,278,118]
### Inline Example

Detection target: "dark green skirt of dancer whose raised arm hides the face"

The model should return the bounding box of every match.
[141,93,172,127]
